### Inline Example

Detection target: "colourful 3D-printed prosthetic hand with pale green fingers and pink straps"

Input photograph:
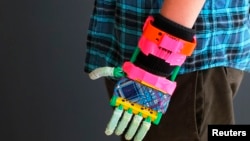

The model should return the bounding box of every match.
[89,16,196,141]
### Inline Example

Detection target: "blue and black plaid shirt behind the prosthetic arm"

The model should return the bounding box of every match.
[85,0,250,74]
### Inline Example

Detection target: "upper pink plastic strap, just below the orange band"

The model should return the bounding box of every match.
[138,36,186,66]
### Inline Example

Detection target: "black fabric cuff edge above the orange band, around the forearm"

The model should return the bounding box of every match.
[152,14,195,42]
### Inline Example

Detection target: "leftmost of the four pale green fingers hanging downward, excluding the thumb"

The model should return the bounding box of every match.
[105,106,123,135]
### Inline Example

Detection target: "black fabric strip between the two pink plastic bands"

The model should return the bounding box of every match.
[134,52,176,77]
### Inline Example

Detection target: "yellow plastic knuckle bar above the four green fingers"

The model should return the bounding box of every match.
[114,97,159,121]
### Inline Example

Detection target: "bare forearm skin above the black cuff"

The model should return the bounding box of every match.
[160,0,205,28]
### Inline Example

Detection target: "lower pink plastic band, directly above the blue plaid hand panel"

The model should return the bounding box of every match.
[122,62,176,95]
